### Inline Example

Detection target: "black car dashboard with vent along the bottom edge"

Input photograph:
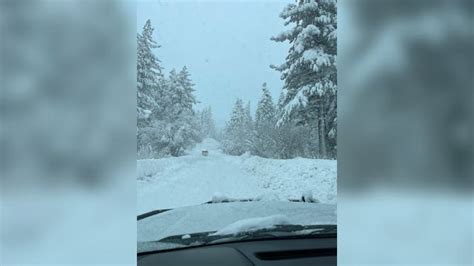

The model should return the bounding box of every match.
[137,237,337,266]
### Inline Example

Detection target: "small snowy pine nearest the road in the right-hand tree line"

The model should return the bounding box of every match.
[222,99,247,155]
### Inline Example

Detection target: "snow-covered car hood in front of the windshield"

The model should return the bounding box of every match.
[137,201,336,242]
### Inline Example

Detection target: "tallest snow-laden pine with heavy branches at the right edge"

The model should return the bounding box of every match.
[272,0,337,158]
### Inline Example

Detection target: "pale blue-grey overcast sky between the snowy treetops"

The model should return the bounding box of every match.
[137,0,292,126]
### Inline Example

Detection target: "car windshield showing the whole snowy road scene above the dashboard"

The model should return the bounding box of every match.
[137,0,337,252]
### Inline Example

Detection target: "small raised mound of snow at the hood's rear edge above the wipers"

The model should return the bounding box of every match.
[211,215,290,235]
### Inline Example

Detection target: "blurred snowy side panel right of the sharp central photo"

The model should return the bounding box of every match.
[338,0,474,265]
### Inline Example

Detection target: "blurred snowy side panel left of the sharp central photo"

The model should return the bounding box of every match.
[0,0,136,265]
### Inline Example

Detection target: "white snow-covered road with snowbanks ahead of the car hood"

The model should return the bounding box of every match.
[137,139,337,213]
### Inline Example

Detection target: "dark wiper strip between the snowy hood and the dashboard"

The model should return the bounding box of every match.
[146,225,337,246]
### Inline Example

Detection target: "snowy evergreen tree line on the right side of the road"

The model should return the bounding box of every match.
[222,0,337,159]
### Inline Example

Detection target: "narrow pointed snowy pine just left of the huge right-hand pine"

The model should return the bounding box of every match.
[254,83,276,158]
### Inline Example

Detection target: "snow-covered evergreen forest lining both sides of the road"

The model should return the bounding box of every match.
[137,0,337,159]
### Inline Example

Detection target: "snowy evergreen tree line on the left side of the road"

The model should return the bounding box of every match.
[137,20,215,159]
